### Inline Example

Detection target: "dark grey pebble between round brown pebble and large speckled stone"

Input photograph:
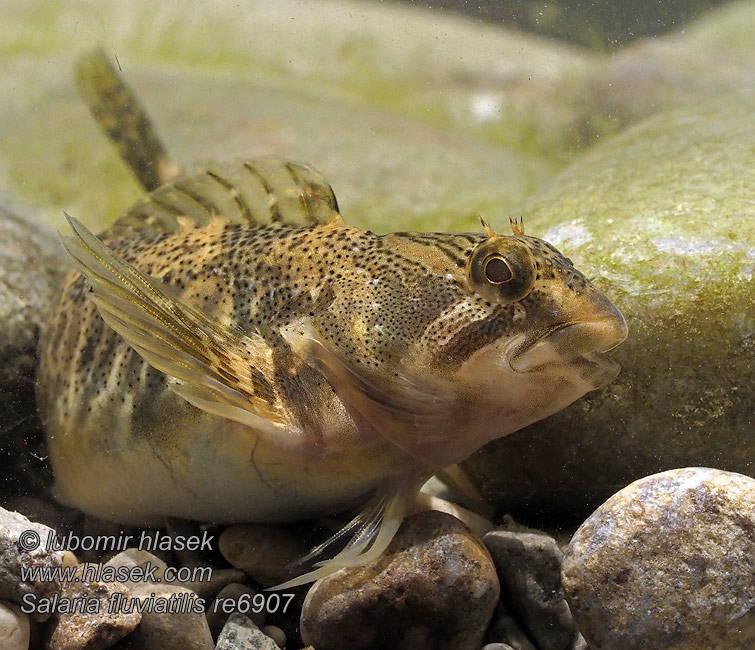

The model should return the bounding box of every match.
[483,530,575,650]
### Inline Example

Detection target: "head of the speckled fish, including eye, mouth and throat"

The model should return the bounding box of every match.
[346,225,628,467]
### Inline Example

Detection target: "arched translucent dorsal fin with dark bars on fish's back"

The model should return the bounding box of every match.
[106,156,338,237]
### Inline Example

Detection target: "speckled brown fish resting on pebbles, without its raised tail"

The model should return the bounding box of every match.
[38,158,627,582]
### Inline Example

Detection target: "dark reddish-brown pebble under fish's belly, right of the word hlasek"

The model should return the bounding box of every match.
[219,524,309,587]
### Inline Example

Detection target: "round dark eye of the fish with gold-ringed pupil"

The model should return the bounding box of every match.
[467,236,535,303]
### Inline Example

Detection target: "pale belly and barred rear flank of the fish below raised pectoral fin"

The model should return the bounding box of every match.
[37,278,395,525]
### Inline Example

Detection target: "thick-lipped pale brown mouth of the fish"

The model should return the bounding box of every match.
[509,313,628,384]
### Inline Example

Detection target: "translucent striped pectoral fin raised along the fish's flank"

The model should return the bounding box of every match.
[63,215,290,438]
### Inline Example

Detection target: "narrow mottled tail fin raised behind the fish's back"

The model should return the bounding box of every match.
[76,48,180,191]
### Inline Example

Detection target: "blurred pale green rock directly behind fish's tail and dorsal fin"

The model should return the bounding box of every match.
[0,60,554,230]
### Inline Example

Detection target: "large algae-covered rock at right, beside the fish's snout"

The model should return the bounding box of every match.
[467,89,755,521]
